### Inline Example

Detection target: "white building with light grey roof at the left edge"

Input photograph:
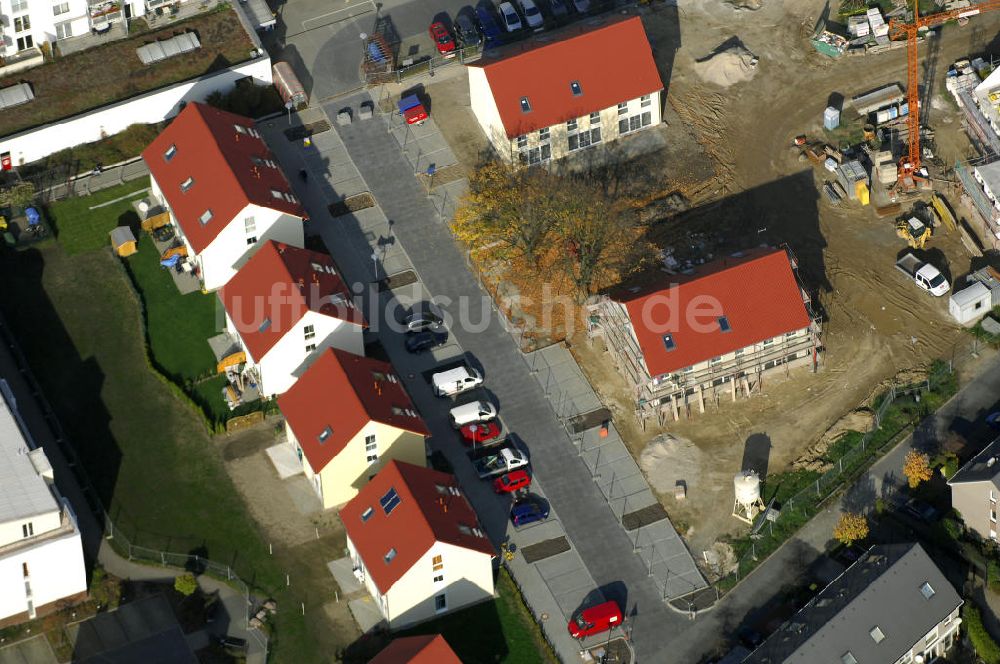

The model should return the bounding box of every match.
[0,380,87,622]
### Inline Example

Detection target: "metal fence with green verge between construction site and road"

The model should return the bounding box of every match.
[718,360,952,587]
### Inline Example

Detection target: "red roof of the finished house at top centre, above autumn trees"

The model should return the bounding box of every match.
[469,16,663,138]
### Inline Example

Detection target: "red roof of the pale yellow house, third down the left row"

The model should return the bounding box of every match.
[278,348,430,473]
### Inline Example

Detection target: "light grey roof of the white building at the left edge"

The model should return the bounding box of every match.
[0,380,59,523]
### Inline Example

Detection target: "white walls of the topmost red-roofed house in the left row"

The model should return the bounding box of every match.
[149,176,305,291]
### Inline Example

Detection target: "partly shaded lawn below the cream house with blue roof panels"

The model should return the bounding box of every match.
[398,570,557,664]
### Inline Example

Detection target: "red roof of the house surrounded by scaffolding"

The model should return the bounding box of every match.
[617,249,810,376]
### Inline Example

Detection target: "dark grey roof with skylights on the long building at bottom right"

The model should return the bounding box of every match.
[743,544,962,664]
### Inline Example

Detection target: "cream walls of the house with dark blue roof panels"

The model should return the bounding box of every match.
[347,537,493,630]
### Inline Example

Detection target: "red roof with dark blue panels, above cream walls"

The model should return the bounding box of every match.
[340,460,496,594]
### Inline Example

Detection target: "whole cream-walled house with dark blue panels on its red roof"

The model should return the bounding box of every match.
[340,461,496,630]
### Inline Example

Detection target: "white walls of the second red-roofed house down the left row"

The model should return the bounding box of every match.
[226,308,365,397]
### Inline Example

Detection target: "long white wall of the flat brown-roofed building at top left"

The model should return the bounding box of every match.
[0,55,271,165]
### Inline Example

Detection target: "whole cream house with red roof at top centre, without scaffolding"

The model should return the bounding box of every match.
[468,16,663,164]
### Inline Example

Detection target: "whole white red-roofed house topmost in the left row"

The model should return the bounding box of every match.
[142,103,305,290]
